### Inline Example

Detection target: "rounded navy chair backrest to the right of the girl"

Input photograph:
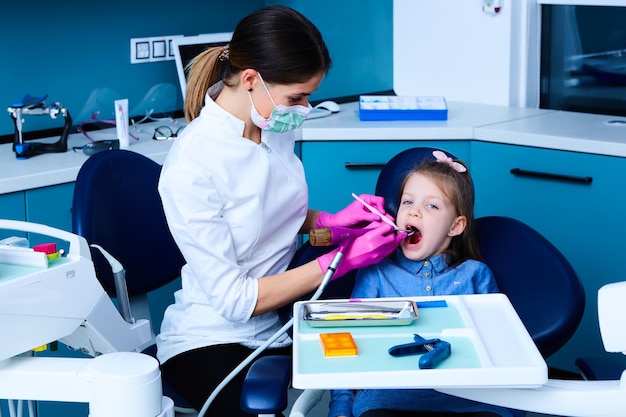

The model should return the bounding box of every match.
[476,216,585,358]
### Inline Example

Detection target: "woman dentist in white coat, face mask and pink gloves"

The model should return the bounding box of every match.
[157,6,406,417]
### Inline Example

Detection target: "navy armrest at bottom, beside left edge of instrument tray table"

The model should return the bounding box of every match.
[241,355,291,414]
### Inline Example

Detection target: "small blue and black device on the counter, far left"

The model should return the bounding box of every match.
[7,94,72,159]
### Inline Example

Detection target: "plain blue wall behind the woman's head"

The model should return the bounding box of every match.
[0,0,393,137]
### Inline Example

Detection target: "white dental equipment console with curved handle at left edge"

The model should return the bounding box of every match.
[0,220,174,417]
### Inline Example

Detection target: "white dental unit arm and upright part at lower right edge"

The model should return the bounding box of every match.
[437,281,626,417]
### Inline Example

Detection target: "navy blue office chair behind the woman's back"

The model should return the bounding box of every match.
[72,150,196,413]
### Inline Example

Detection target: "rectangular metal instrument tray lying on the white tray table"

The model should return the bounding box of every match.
[302,299,419,327]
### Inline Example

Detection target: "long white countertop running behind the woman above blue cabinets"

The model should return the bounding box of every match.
[0,102,626,194]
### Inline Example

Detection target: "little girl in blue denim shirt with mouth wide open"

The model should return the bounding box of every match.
[329,151,523,417]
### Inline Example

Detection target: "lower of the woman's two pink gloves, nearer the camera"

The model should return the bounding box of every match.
[317,221,407,280]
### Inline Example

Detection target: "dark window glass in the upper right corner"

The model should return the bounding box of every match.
[539,5,626,116]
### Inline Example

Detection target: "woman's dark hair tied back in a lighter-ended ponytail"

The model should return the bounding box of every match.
[185,6,331,121]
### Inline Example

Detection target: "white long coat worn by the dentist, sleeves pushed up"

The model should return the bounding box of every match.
[155,86,308,363]
